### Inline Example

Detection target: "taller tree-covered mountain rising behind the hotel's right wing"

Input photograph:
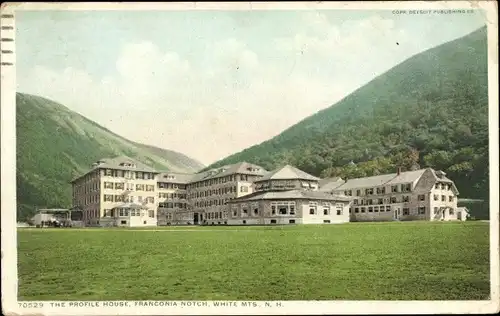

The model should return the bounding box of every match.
[206,27,489,215]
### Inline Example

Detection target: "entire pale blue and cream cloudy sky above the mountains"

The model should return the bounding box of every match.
[16,10,485,165]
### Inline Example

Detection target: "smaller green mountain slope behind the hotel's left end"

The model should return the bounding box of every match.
[16,93,204,219]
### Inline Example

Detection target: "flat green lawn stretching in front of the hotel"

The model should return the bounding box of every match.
[18,222,490,300]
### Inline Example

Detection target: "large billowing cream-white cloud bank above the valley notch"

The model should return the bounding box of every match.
[19,12,438,164]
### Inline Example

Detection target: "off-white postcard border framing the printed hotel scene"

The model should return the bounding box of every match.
[0,1,500,315]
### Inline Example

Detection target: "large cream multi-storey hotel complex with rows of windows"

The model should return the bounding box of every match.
[71,156,465,226]
